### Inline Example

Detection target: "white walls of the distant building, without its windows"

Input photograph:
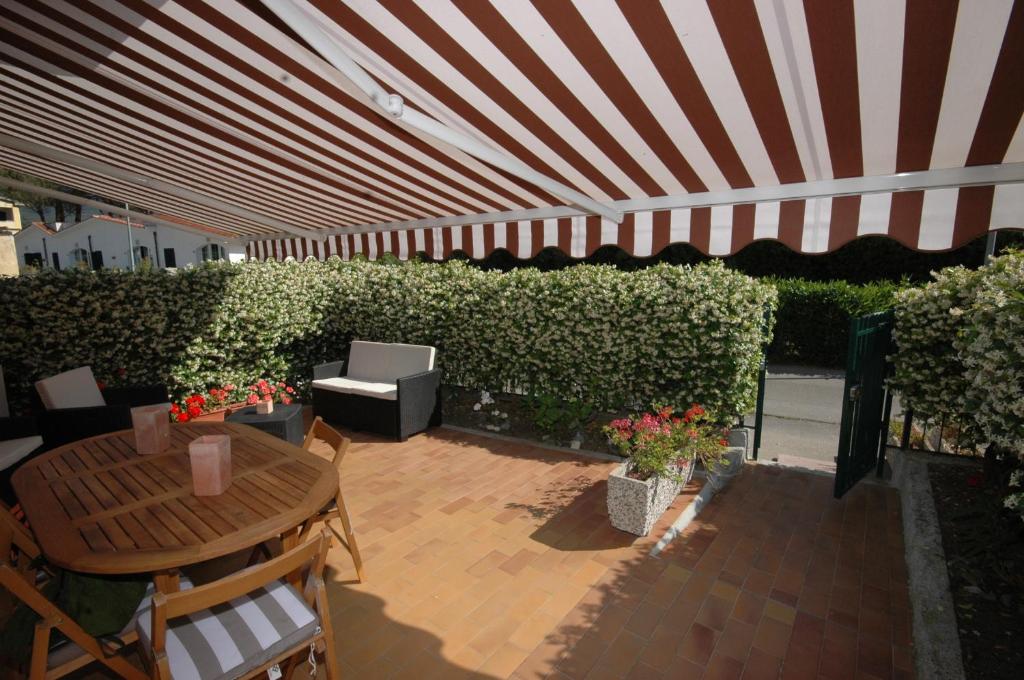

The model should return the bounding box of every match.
[14,217,245,271]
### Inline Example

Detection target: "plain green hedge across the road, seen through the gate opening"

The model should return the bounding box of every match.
[764,279,905,367]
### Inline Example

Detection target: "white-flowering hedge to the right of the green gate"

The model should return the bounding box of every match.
[892,253,1024,456]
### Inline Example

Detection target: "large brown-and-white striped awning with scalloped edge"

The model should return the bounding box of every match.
[0,0,1024,258]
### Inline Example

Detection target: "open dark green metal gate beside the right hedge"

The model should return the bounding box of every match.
[835,311,893,498]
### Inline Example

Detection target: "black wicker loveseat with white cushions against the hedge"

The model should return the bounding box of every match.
[312,340,441,441]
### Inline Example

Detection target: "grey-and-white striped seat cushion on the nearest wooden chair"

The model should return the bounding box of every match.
[136,581,319,680]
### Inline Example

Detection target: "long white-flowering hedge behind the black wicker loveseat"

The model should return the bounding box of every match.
[0,258,776,414]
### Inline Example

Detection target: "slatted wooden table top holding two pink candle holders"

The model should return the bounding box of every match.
[11,423,338,573]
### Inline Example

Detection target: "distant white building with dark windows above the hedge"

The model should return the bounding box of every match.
[14,215,246,272]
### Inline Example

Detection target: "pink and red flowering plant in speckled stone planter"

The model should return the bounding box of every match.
[604,403,727,536]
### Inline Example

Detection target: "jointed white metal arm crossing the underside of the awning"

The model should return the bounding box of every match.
[263,0,623,223]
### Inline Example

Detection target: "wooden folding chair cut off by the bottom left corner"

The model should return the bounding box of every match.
[0,504,145,680]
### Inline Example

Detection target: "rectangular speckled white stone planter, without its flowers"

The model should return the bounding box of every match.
[608,462,693,536]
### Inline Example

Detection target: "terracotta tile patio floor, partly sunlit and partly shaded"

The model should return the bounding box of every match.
[301,429,912,680]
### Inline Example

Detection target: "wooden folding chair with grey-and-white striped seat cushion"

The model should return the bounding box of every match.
[138,528,339,680]
